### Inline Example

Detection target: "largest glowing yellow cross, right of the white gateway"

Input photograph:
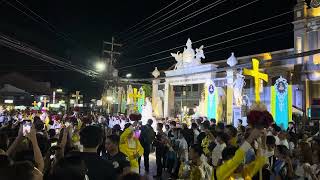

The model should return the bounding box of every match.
[243,58,268,102]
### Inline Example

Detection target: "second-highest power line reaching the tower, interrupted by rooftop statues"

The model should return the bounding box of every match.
[118,23,291,70]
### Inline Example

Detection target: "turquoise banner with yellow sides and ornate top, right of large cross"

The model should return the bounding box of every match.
[271,77,292,130]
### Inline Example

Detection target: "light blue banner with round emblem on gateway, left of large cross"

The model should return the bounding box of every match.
[206,83,218,119]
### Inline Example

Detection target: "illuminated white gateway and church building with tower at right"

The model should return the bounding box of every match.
[153,0,320,128]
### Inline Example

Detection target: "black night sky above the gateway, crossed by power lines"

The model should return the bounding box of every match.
[0,0,294,97]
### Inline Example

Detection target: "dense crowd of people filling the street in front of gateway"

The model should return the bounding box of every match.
[0,105,320,180]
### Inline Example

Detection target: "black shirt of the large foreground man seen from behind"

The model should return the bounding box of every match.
[77,152,116,180]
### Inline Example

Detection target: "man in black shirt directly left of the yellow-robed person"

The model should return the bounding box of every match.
[104,134,130,176]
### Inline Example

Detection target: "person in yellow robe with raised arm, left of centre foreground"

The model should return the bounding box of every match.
[119,124,144,173]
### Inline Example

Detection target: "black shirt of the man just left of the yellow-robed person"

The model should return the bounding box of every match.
[104,152,130,176]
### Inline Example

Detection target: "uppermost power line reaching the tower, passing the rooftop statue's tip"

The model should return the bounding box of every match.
[124,11,293,60]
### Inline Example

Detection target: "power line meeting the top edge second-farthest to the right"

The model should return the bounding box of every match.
[126,0,228,47]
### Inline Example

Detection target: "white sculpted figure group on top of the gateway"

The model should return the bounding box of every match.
[171,39,205,69]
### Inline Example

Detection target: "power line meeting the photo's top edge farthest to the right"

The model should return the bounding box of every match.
[132,0,260,49]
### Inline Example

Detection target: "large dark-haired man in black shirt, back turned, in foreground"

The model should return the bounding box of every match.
[79,125,116,180]
